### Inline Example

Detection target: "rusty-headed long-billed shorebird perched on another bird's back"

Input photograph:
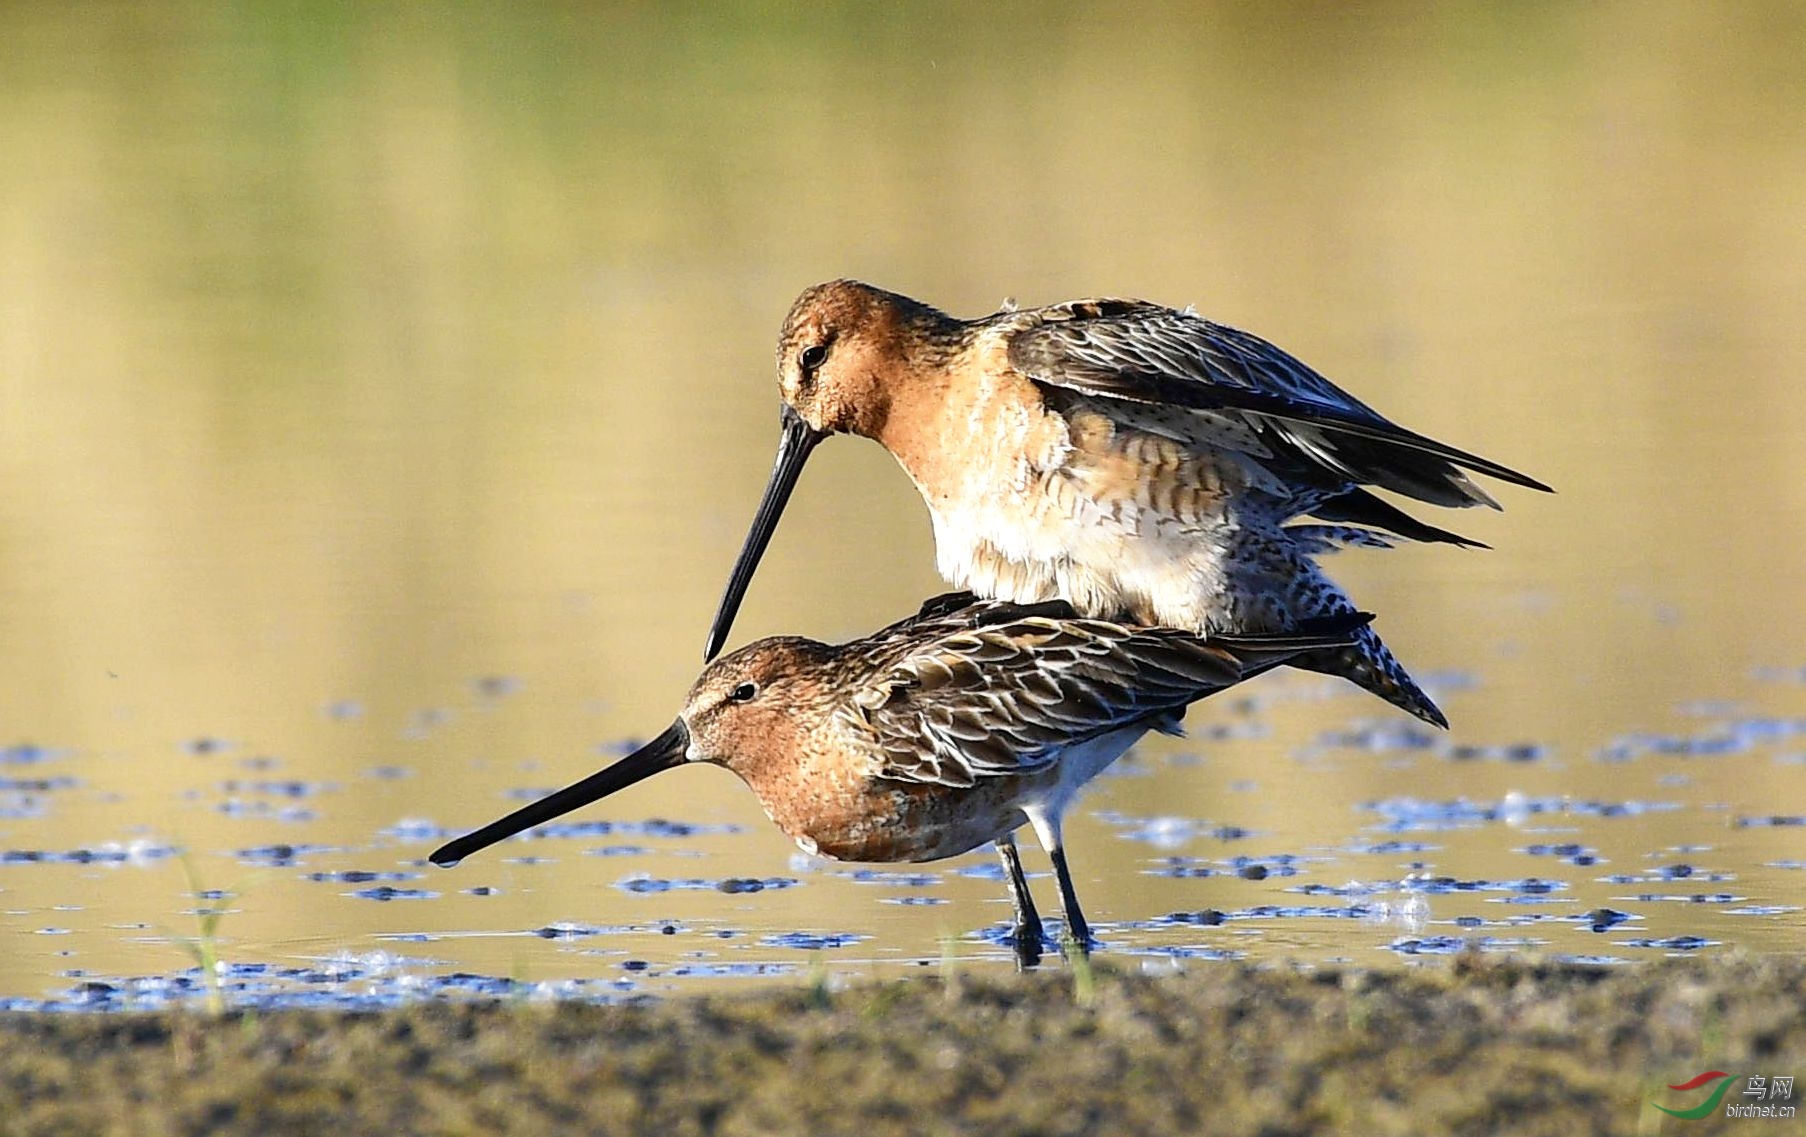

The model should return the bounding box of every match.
[706,280,1550,726]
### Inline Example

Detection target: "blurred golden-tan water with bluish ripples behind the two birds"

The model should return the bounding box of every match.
[0,2,1806,994]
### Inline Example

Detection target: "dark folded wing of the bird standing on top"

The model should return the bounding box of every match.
[1010,300,1548,505]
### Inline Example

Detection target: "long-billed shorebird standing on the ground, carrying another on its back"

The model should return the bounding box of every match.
[432,594,1367,966]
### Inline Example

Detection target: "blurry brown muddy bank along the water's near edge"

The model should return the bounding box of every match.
[0,958,1806,1137]
